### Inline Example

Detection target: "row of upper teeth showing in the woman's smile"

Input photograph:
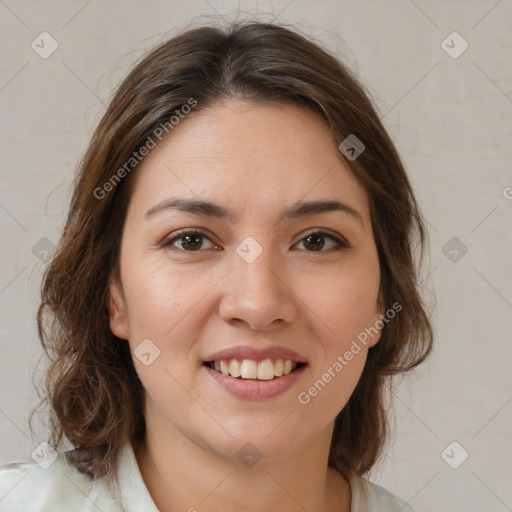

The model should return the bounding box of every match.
[208,359,297,380]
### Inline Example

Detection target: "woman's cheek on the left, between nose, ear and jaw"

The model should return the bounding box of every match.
[120,258,218,394]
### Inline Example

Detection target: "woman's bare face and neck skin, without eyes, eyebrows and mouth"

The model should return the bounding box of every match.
[109,100,383,512]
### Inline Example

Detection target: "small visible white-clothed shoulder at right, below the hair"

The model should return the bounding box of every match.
[351,476,414,512]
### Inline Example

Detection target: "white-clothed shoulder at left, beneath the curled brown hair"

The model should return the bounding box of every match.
[0,452,123,512]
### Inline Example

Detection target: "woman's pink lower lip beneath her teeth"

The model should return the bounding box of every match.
[203,365,306,400]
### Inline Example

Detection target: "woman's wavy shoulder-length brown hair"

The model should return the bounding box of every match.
[30,22,433,477]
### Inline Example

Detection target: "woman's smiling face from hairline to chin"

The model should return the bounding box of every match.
[110,100,382,464]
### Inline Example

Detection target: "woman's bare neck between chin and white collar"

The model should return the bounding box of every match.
[134,412,351,512]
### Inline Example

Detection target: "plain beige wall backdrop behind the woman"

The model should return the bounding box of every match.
[0,0,512,512]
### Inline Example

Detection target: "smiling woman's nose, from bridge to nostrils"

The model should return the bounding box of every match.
[219,242,298,330]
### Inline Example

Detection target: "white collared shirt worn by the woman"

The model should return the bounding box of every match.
[0,444,414,512]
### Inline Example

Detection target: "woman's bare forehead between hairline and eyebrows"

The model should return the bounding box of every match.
[126,100,368,223]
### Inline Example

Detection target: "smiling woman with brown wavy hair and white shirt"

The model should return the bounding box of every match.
[0,23,432,512]
